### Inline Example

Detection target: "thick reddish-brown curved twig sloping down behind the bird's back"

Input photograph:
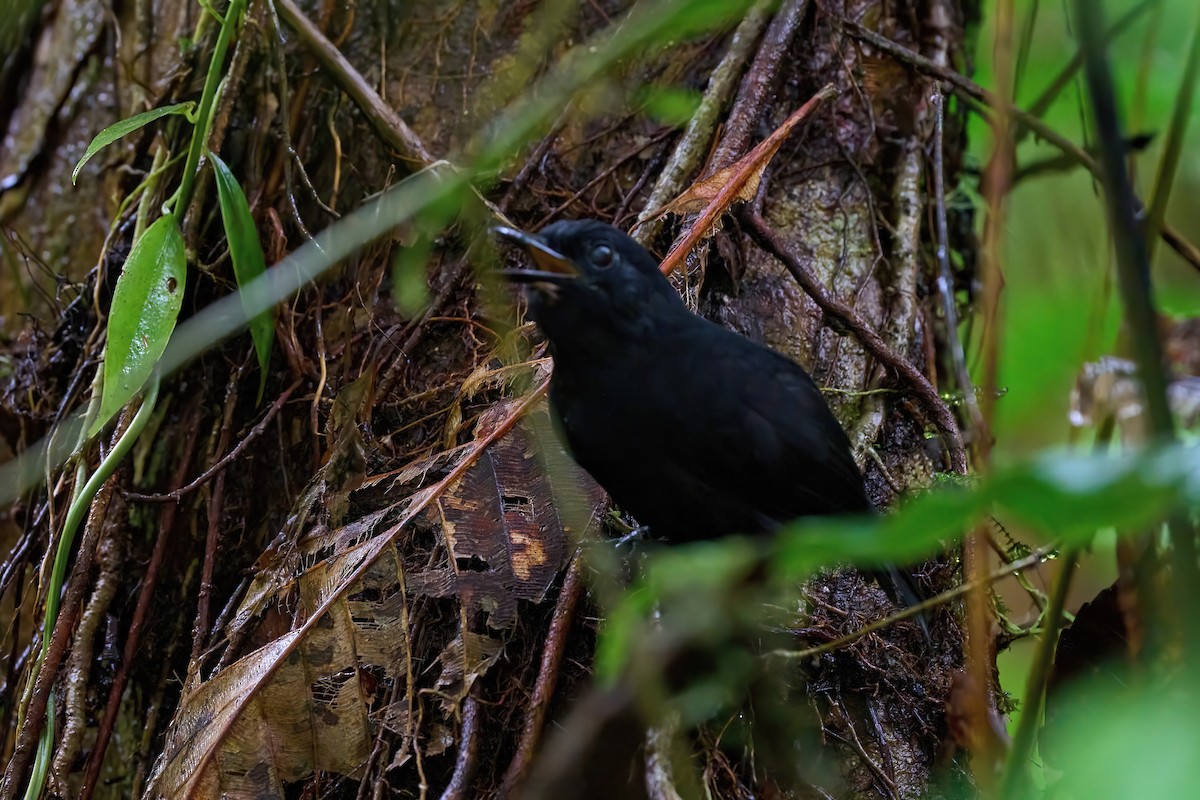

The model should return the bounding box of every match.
[743,209,967,475]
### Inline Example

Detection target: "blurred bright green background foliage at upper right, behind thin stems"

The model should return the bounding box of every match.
[968,0,1200,459]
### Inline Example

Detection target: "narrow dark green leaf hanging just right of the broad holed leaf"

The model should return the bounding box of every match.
[209,152,275,402]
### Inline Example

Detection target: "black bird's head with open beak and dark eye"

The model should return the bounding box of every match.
[496,219,685,344]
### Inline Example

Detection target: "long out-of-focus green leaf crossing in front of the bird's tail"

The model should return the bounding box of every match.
[596,445,1200,678]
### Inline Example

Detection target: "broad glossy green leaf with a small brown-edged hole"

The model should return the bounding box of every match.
[88,213,187,437]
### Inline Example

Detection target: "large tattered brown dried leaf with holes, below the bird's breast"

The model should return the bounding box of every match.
[146,386,602,798]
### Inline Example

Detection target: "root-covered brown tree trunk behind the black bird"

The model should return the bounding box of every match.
[0,0,976,798]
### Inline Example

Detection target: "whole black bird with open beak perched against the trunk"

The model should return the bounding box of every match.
[497,219,914,602]
